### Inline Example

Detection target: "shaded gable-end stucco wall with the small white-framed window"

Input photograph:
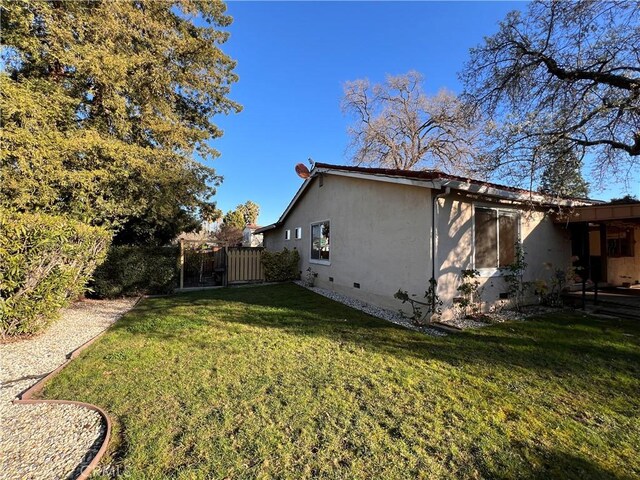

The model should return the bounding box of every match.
[265,175,431,310]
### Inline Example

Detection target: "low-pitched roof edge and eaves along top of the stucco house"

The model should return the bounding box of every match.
[255,162,603,233]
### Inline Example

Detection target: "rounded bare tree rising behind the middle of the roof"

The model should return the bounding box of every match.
[342,71,476,173]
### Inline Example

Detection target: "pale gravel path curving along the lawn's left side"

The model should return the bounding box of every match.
[0,299,136,479]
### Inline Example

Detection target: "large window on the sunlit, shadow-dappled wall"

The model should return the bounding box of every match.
[474,208,520,269]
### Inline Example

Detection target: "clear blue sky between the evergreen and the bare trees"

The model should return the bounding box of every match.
[211,2,636,225]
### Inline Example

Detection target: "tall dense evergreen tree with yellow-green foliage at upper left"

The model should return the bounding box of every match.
[0,0,241,228]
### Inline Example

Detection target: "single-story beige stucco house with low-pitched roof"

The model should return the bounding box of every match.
[255,163,640,318]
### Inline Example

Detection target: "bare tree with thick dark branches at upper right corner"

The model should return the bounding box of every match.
[461,0,640,191]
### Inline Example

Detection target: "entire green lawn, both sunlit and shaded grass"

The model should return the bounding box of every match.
[44,285,640,480]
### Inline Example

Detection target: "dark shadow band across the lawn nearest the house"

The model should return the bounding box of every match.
[114,285,640,382]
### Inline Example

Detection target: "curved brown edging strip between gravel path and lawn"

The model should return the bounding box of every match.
[11,297,143,480]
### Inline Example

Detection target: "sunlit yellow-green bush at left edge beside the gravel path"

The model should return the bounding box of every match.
[0,208,111,337]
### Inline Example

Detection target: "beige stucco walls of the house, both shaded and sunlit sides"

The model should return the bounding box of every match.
[264,174,571,318]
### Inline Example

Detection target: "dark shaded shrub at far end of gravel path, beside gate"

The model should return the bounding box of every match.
[91,245,180,298]
